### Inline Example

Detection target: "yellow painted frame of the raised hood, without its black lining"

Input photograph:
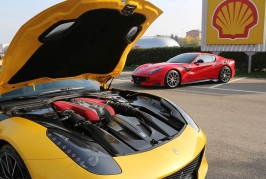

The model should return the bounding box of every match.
[0,0,162,94]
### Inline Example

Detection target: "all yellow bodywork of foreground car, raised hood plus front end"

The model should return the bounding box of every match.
[0,0,208,179]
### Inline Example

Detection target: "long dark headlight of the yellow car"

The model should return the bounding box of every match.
[47,129,122,175]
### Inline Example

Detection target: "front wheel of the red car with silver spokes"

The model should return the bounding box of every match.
[164,70,181,88]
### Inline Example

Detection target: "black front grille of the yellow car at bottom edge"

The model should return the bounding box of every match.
[165,150,204,179]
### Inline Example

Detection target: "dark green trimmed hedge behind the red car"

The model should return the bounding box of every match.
[126,47,266,70]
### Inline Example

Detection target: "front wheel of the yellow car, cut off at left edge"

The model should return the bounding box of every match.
[0,144,31,179]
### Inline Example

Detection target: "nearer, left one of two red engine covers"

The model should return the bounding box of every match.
[53,101,100,123]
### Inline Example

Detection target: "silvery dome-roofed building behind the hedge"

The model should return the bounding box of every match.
[134,36,179,48]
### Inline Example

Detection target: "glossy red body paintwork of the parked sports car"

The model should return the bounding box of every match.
[132,53,235,86]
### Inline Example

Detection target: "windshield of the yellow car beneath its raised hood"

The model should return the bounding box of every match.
[1,80,100,98]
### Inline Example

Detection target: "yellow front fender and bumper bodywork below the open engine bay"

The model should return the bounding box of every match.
[0,117,208,179]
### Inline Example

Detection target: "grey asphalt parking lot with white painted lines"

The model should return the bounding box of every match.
[112,72,266,179]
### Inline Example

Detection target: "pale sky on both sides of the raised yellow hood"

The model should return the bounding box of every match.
[0,0,202,44]
